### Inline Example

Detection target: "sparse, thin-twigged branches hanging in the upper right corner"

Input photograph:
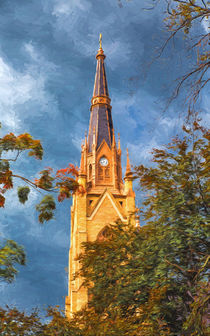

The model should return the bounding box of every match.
[147,0,210,117]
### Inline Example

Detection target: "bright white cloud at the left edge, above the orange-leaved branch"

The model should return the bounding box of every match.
[0,43,57,132]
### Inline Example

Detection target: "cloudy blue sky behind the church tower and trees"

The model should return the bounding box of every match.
[0,0,209,316]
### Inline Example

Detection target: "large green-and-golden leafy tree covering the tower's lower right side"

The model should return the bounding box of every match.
[75,123,209,336]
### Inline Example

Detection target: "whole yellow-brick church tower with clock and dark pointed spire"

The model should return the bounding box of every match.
[66,37,136,317]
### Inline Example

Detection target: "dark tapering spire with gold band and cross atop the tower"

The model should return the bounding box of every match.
[88,34,113,152]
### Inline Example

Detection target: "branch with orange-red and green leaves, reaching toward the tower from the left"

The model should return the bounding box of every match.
[0,124,79,223]
